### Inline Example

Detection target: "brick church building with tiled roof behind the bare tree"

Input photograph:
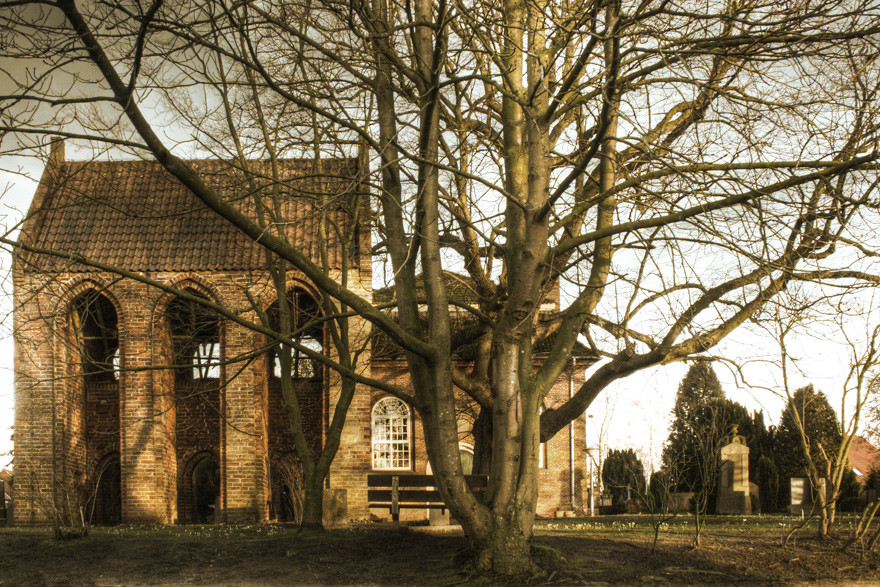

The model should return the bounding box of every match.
[13,142,587,526]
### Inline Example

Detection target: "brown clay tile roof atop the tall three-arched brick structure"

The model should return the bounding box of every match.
[19,159,367,272]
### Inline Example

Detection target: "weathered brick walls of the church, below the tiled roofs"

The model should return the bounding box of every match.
[14,260,586,525]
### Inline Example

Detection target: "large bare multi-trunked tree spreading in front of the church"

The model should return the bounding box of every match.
[0,0,880,573]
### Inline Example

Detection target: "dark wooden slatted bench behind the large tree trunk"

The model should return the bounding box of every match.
[367,472,489,526]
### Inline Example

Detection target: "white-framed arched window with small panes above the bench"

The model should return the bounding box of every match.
[372,397,412,470]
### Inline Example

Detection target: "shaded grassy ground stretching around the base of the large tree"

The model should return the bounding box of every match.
[0,516,880,587]
